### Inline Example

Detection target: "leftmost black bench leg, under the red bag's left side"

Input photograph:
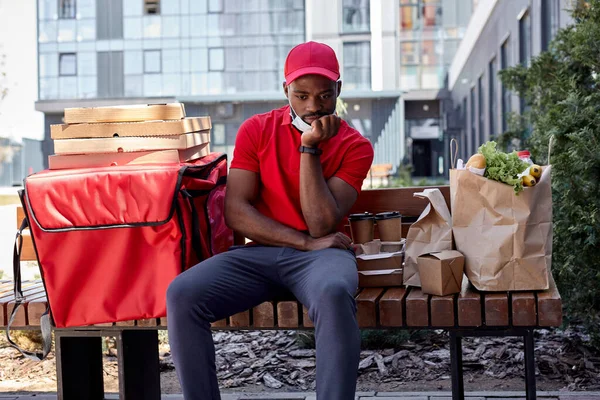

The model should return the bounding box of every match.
[55,331,104,400]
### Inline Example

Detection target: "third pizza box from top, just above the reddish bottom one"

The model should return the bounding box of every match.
[54,131,210,154]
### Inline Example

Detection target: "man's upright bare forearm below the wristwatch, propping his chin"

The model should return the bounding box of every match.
[300,153,340,237]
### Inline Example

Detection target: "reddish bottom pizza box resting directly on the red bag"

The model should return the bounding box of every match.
[48,143,210,169]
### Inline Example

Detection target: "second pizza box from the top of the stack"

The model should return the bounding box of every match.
[50,117,212,139]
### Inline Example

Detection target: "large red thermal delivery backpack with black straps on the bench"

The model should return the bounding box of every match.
[7,153,233,358]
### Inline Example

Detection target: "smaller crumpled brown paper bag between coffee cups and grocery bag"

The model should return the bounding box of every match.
[404,189,452,287]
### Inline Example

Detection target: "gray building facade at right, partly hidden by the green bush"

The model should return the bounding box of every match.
[445,0,573,167]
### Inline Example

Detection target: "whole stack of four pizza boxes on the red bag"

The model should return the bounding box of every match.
[48,103,211,169]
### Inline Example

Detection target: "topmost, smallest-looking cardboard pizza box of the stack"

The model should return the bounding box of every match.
[65,103,185,124]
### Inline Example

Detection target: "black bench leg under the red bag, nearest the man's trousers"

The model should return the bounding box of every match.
[117,330,160,400]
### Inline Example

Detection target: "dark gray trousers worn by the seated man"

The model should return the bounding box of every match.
[167,246,360,400]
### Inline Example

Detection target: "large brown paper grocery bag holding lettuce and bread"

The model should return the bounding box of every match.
[450,166,552,291]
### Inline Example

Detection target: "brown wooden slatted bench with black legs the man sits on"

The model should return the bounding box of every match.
[0,186,562,400]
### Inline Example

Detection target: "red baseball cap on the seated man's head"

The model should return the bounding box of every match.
[283,42,340,85]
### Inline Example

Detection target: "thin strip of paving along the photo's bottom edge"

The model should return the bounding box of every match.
[0,392,600,400]
